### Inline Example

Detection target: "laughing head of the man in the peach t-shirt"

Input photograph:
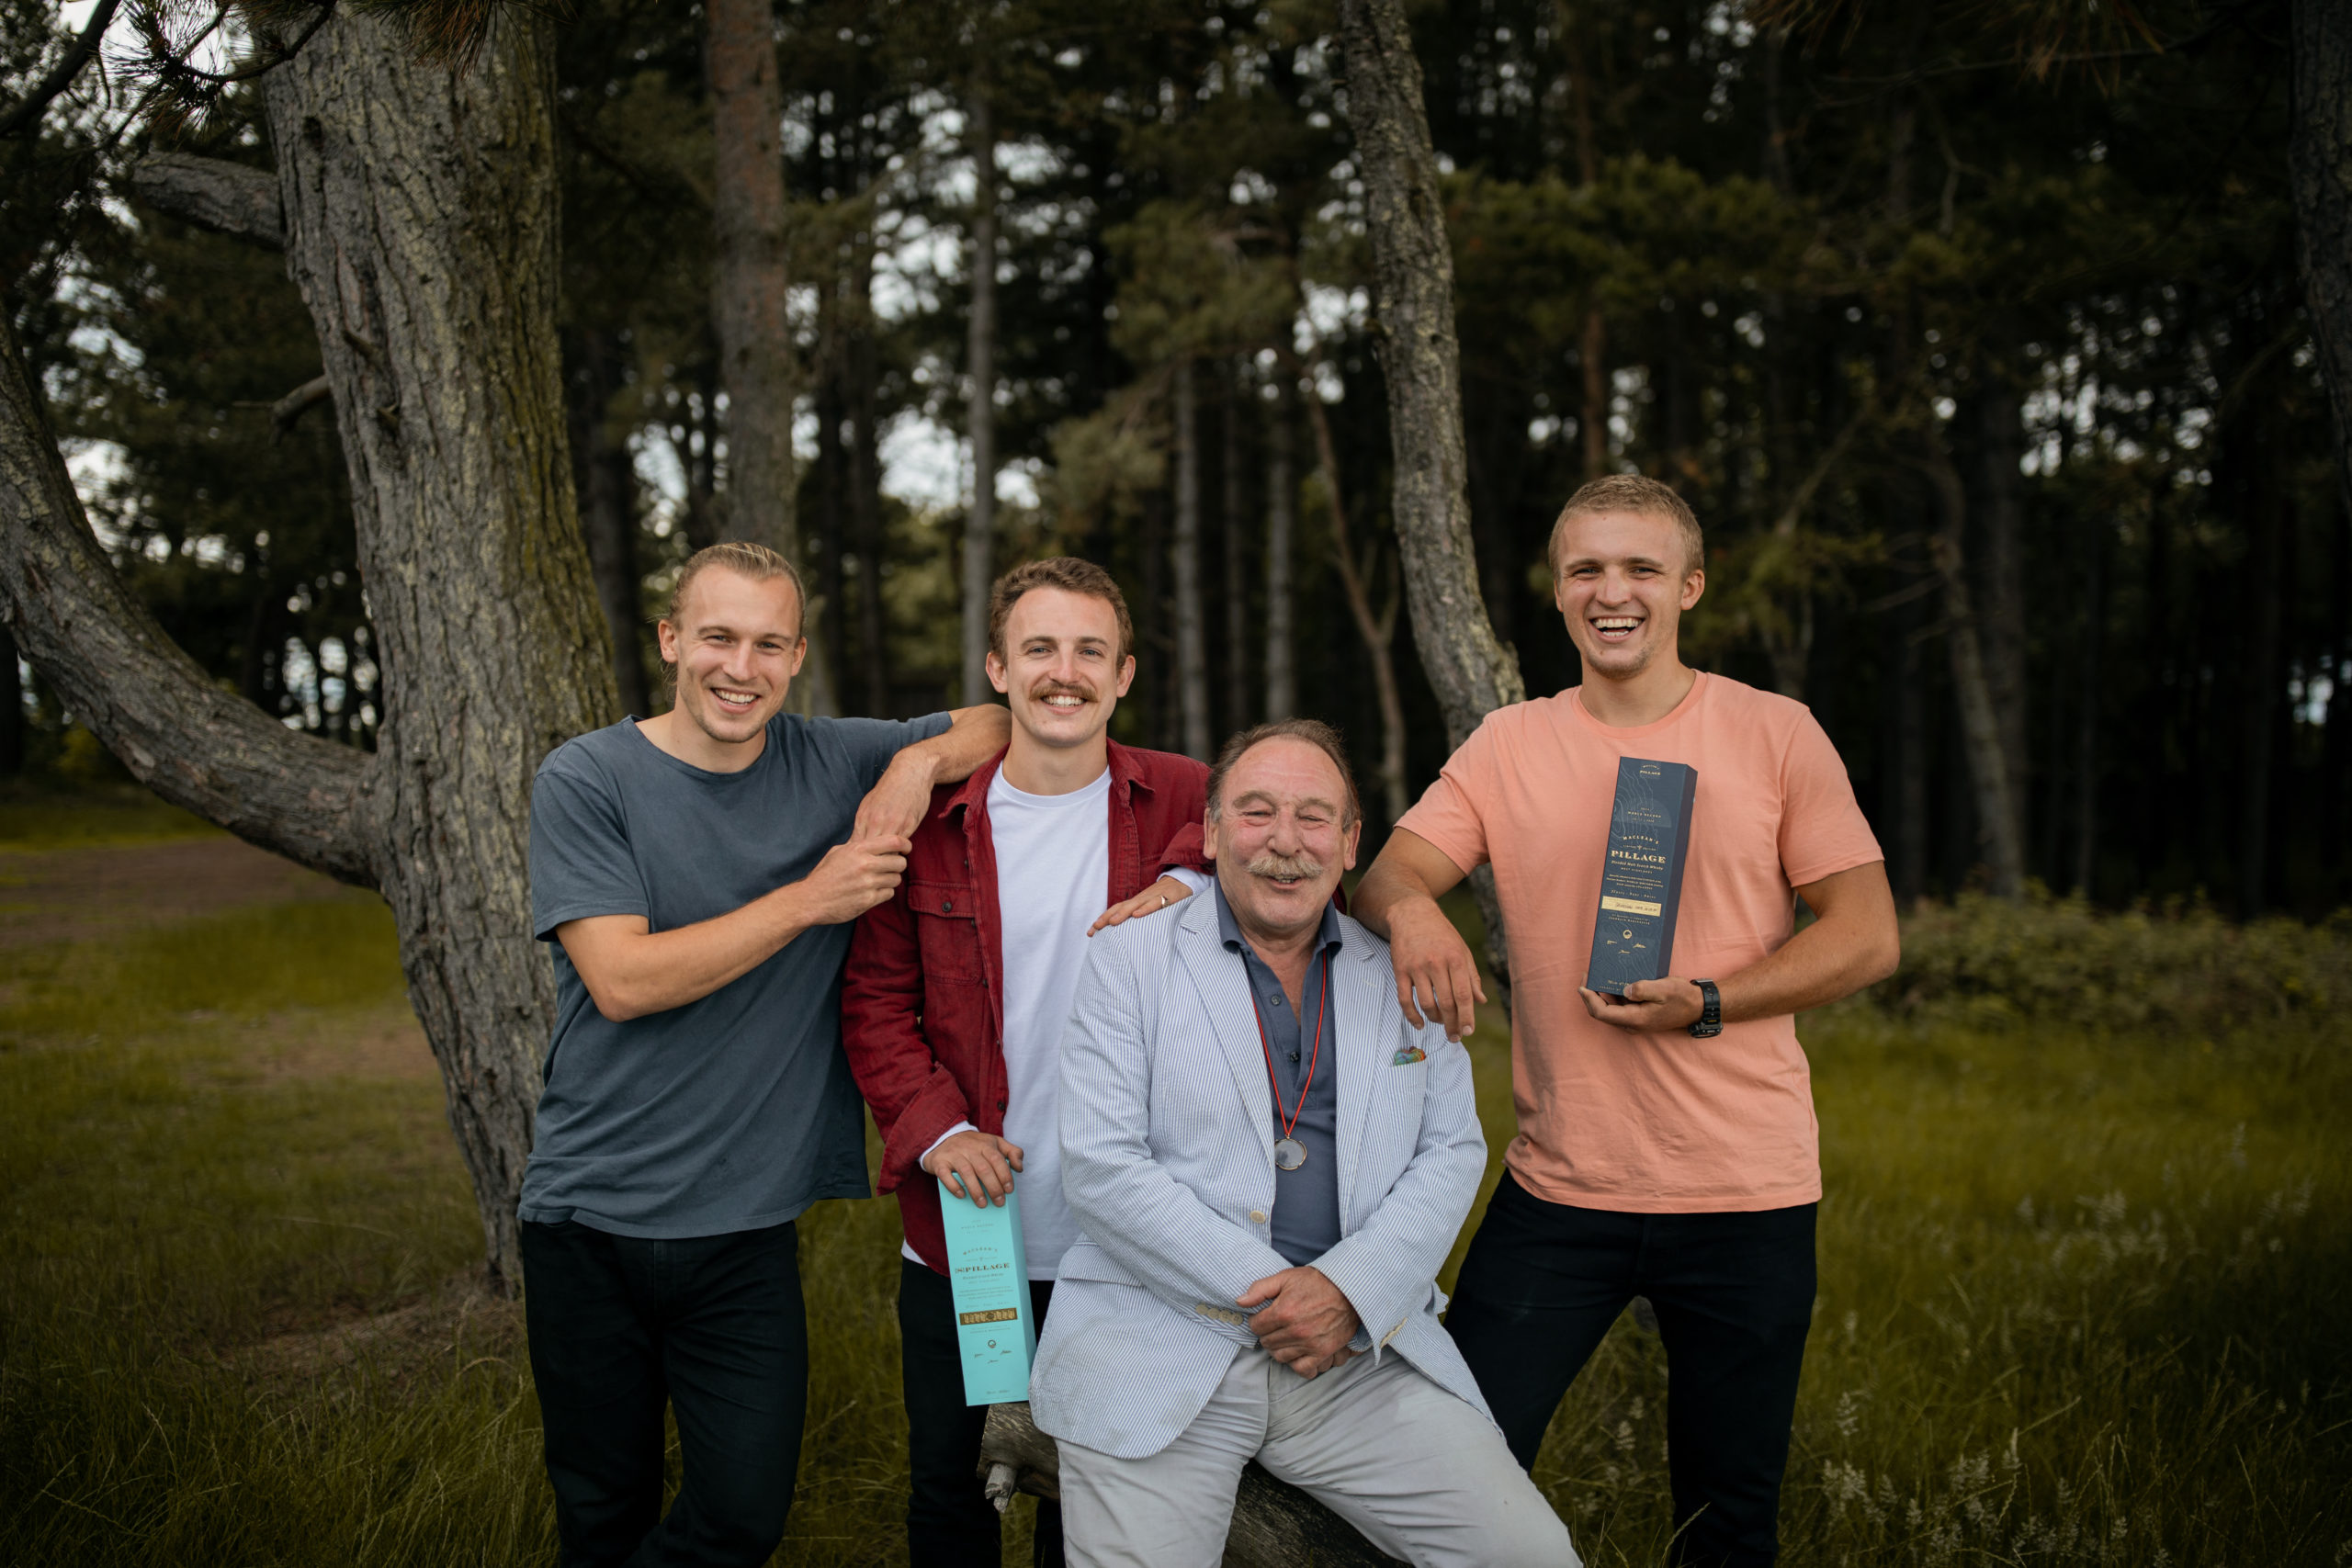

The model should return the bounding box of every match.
[1553,513,1708,680]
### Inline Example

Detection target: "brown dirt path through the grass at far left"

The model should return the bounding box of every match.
[0,837,357,952]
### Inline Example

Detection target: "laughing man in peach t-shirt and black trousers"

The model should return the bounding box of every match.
[1355,475,1898,1568]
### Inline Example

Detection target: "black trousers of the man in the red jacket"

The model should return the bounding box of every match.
[899,1258,1061,1568]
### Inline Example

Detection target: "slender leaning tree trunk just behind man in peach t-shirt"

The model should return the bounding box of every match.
[1339,0,1526,1009]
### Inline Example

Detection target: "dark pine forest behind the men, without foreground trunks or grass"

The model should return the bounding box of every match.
[0,0,2352,915]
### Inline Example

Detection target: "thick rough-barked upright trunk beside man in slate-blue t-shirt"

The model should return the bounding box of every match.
[263,12,618,1286]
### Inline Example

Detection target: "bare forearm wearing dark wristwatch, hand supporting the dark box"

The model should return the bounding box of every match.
[1583,861,1903,1030]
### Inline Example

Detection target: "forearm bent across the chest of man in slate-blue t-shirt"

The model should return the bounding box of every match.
[555,837,908,1022]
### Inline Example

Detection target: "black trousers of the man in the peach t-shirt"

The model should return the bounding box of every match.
[1446,1173,1818,1568]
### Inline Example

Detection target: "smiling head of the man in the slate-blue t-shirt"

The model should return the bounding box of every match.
[659,567,809,748]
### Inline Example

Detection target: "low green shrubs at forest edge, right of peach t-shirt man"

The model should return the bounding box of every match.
[1870,894,2352,1034]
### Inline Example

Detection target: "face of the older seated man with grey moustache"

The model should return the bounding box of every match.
[1206,736,1364,941]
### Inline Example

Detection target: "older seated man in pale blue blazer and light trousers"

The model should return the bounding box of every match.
[1030,719,1576,1568]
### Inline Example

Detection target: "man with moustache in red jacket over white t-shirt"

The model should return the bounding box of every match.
[842,558,1209,1568]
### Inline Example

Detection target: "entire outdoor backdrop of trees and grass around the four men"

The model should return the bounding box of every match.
[0,0,2352,1568]
